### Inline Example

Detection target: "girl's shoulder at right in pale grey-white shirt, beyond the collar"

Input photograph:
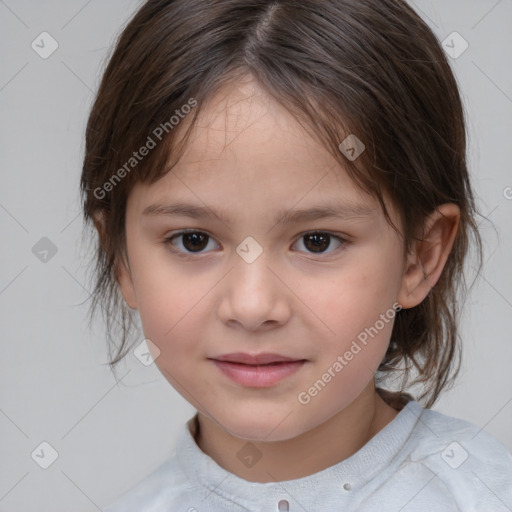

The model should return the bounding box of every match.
[409,406,512,511]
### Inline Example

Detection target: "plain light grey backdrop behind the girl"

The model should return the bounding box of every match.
[0,0,512,512]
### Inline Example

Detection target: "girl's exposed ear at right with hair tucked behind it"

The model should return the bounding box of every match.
[397,203,460,309]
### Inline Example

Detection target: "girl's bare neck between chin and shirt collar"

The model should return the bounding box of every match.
[195,383,398,483]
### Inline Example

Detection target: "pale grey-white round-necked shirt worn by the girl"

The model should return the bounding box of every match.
[104,401,512,512]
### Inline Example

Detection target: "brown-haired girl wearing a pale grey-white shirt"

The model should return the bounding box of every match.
[81,0,512,512]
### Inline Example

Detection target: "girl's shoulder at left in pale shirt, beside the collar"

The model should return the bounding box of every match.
[103,456,190,512]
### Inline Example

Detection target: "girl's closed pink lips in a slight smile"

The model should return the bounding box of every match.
[212,353,306,388]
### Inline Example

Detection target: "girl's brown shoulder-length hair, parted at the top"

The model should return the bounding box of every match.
[81,0,482,406]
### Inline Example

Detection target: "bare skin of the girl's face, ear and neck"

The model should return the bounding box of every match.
[115,74,459,482]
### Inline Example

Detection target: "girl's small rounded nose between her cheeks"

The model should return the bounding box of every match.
[218,251,291,331]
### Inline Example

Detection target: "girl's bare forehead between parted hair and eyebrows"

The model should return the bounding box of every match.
[129,78,396,226]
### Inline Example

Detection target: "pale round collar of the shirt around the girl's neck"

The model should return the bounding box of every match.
[176,401,423,511]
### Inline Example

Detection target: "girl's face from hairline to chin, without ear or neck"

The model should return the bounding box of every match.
[121,76,410,441]
